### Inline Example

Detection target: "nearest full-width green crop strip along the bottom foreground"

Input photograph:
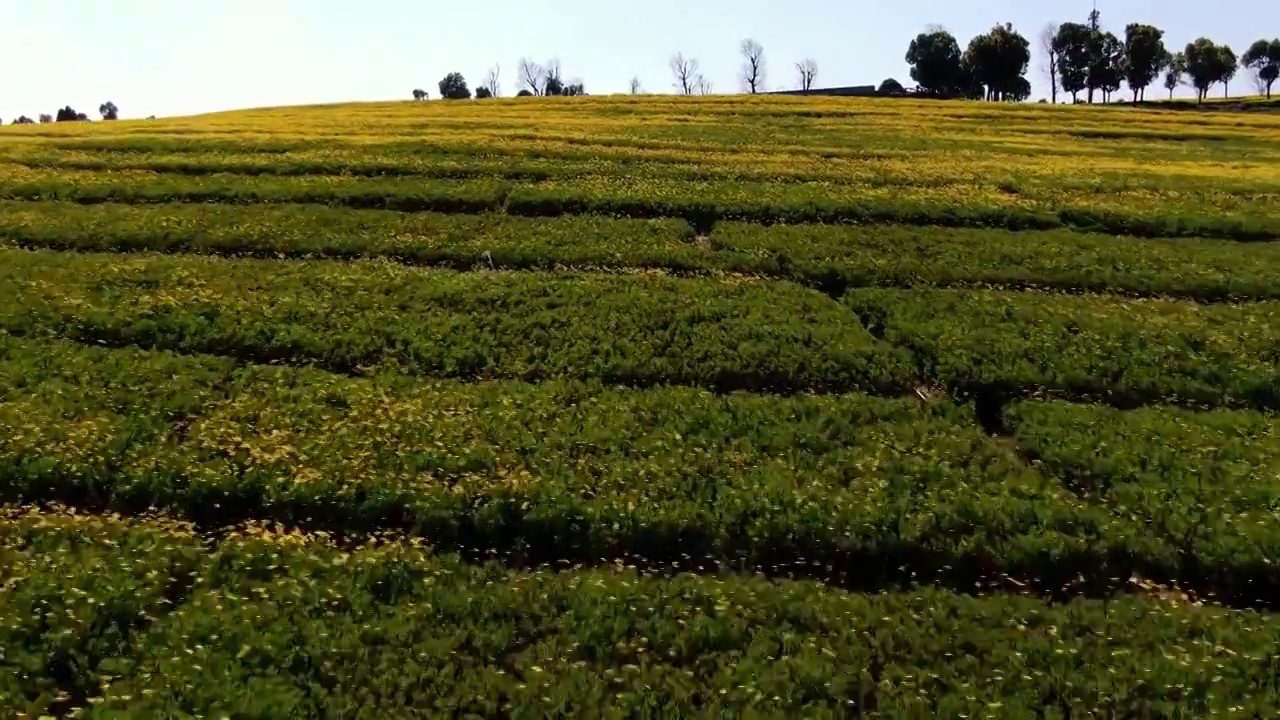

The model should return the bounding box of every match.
[0,512,1280,717]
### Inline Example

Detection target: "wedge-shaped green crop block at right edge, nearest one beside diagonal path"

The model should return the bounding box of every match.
[1007,402,1280,602]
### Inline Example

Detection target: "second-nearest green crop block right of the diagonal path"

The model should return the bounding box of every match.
[844,288,1280,409]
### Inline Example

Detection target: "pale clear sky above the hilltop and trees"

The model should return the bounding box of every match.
[0,0,1280,122]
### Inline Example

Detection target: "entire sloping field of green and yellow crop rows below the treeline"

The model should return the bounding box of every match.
[0,97,1280,719]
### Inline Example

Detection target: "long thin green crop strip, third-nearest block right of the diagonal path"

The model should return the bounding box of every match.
[709,217,1280,302]
